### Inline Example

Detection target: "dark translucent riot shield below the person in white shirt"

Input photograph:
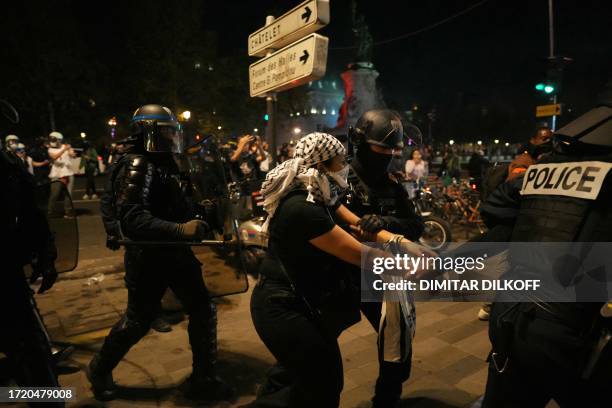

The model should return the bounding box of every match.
[47,180,79,272]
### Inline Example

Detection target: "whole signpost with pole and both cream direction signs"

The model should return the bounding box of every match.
[248,0,330,161]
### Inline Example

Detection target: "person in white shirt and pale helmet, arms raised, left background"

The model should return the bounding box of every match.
[48,132,76,214]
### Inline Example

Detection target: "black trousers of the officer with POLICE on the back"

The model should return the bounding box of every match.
[482,303,612,408]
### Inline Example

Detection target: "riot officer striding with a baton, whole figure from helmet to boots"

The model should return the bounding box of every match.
[88,105,232,400]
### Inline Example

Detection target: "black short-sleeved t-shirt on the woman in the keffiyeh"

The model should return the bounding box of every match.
[261,190,341,299]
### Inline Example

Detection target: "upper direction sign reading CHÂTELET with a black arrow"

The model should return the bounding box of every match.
[248,0,329,57]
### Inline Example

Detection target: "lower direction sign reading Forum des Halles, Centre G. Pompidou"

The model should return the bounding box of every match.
[249,34,329,96]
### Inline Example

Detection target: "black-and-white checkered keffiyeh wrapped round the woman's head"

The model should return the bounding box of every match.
[261,132,346,231]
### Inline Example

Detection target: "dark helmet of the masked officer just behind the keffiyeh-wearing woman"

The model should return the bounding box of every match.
[349,109,404,149]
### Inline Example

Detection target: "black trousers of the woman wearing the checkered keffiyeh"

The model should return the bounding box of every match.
[251,280,344,408]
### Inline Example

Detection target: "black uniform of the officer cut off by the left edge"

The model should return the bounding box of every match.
[0,152,64,406]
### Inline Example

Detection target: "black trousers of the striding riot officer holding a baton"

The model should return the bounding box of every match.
[96,248,217,376]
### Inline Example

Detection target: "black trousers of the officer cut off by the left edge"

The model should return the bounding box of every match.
[0,270,64,407]
